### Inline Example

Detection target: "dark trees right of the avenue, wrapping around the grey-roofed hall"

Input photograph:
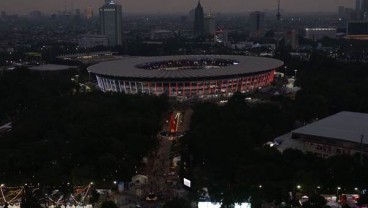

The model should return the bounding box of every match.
[183,57,368,207]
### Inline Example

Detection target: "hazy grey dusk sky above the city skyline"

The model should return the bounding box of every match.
[0,0,355,14]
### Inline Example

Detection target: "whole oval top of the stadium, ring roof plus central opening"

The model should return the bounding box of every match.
[88,55,283,81]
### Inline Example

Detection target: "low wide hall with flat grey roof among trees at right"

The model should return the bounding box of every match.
[275,111,368,157]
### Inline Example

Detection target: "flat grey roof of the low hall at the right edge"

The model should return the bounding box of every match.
[293,111,368,144]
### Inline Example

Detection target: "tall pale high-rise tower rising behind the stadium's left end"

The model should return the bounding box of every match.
[99,0,123,46]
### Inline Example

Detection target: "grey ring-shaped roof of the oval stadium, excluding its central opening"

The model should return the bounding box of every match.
[87,55,284,79]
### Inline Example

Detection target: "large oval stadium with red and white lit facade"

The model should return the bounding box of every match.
[87,55,283,100]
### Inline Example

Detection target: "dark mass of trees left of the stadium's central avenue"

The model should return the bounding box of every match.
[0,68,168,185]
